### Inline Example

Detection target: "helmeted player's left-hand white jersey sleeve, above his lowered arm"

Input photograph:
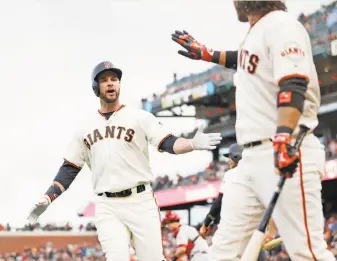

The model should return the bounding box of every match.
[64,129,87,169]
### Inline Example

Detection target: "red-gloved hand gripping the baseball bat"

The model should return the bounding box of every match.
[273,133,299,178]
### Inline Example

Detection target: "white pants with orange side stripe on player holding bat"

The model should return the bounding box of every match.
[210,134,335,261]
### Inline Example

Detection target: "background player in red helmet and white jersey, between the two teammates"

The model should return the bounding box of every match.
[162,211,208,261]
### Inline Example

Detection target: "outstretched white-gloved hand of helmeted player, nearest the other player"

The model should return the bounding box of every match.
[191,128,222,150]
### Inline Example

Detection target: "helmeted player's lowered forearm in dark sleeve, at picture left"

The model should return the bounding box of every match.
[45,161,81,202]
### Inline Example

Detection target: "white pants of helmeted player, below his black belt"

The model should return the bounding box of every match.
[95,185,166,261]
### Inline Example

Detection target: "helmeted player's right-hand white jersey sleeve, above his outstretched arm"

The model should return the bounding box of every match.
[142,112,173,152]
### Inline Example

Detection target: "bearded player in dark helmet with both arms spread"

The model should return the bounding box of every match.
[29,62,221,261]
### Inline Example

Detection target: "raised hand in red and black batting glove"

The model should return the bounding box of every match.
[172,30,214,62]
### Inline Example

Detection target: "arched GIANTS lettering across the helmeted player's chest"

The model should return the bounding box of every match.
[84,126,135,149]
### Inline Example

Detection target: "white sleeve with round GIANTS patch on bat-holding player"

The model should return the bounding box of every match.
[267,20,312,85]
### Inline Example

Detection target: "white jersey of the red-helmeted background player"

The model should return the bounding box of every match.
[176,225,208,256]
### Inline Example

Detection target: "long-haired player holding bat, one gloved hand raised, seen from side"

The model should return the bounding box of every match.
[172,1,335,261]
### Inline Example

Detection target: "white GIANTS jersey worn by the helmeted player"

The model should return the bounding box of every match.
[64,106,171,193]
